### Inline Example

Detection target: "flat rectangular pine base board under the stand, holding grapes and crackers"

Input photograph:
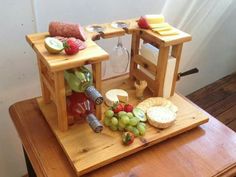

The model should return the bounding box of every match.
[37,76,208,175]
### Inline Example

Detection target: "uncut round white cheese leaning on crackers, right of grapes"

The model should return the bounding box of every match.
[147,106,176,129]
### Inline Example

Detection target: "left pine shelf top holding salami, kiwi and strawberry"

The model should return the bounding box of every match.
[26,33,109,72]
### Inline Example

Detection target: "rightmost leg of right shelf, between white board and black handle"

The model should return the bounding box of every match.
[171,43,183,96]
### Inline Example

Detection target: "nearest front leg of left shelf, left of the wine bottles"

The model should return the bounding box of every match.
[55,71,68,131]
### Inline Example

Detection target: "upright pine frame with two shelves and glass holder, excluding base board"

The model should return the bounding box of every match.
[26,19,191,131]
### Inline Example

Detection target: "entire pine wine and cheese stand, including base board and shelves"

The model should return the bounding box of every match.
[26,19,208,175]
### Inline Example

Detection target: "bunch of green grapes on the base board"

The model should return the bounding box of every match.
[104,109,146,137]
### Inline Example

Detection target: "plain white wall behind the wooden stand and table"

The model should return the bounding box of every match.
[0,0,236,177]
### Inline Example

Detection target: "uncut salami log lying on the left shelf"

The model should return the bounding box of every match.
[49,21,86,41]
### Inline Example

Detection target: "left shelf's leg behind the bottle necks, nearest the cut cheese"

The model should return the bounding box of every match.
[92,62,102,119]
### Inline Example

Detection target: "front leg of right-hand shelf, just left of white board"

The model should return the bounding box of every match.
[154,47,170,96]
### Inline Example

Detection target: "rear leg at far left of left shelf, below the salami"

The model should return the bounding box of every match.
[37,56,51,104]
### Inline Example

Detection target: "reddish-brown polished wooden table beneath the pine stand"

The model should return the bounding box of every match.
[10,99,236,177]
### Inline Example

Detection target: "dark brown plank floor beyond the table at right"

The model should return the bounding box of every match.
[187,73,236,131]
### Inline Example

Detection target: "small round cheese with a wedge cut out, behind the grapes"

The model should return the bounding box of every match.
[105,89,128,106]
